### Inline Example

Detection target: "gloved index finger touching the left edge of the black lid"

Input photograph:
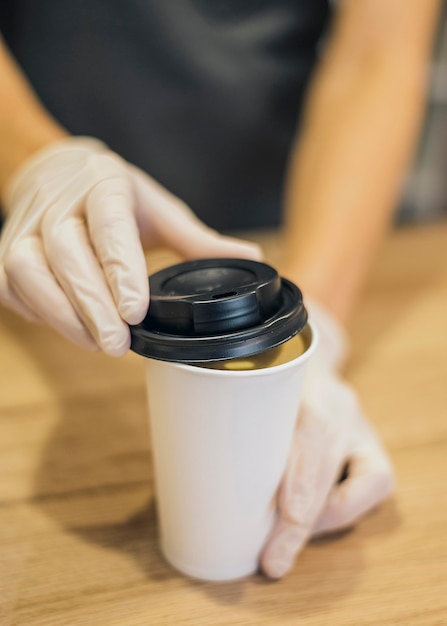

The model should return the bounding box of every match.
[86,154,149,324]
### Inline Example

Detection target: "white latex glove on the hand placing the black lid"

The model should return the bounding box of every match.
[0,137,261,356]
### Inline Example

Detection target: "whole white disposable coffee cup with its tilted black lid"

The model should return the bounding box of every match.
[131,259,316,581]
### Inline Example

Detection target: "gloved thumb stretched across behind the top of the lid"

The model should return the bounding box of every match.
[132,168,262,261]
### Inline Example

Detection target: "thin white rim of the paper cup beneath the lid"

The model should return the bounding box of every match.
[158,322,319,378]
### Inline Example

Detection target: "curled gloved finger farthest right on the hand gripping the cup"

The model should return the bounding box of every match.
[313,451,394,534]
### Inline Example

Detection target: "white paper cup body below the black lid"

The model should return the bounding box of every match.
[146,325,316,581]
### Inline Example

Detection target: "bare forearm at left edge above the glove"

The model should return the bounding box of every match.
[0,37,67,208]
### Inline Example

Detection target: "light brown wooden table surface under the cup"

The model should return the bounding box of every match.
[0,226,447,626]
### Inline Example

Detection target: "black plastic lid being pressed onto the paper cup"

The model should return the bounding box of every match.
[130,259,307,363]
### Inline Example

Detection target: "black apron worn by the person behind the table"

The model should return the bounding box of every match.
[0,0,329,230]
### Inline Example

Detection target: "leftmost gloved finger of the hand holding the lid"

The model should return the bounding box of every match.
[5,237,98,351]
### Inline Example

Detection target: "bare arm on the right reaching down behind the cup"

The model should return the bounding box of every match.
[283,0,440,322]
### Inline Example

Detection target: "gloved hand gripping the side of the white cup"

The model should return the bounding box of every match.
[261,302,394,578]
